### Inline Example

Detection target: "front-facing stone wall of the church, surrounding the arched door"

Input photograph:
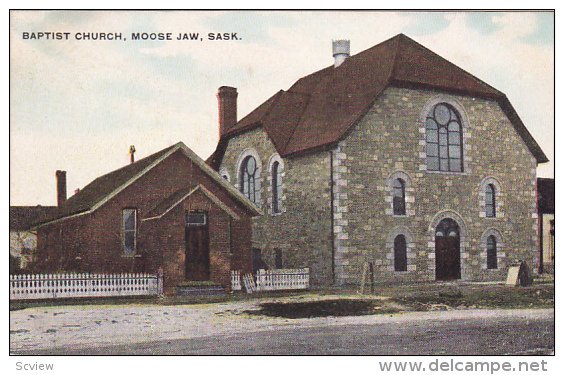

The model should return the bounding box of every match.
[333,88,538,284]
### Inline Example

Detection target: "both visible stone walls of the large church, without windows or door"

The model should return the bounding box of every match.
[216,87,537,285]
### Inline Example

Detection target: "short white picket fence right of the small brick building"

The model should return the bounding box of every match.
[231,268,309,293]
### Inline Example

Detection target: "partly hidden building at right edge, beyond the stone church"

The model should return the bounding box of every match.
[537,178,555,273]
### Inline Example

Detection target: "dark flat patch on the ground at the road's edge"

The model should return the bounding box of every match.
[245,299,401,319]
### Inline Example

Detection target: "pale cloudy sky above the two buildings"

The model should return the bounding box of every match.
[10,11,554,205]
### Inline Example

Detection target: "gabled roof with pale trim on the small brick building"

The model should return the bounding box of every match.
[36,142,261,225]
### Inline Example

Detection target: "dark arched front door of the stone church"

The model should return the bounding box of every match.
[435,219,460,280]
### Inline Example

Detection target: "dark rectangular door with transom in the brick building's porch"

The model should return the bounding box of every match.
[185,212,210,281]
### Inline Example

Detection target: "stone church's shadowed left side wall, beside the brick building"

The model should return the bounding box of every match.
[219,128,333,285]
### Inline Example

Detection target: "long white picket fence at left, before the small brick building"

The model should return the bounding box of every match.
[10,273,163,300]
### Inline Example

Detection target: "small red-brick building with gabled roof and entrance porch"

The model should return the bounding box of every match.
[34,143,259,294]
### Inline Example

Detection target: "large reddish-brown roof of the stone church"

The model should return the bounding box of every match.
[208,34,548,168]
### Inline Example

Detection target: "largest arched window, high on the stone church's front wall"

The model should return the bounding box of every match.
[425,103,463,172]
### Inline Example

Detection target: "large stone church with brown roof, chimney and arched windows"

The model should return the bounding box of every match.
[208,34,548,285]
